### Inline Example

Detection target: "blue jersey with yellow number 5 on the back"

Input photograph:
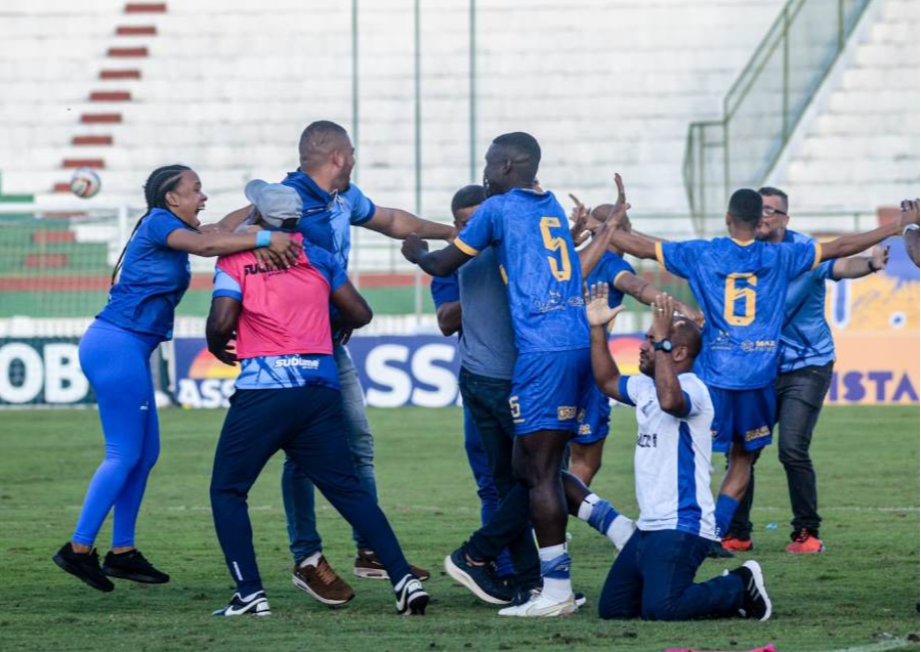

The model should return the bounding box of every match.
[455,189,591,355]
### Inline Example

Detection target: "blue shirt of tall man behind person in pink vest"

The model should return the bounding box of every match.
[282,171,377,271]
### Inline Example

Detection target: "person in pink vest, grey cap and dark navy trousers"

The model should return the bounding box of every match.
[208,182,429,617]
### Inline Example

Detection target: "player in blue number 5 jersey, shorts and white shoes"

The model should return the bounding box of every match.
[403,133,624,617]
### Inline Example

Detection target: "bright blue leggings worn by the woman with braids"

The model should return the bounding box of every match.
[73,321,160,548]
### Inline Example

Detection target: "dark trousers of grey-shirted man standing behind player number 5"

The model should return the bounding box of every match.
[460,369,540,585]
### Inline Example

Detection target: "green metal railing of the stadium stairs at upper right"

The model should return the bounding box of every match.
[684,0,871,233]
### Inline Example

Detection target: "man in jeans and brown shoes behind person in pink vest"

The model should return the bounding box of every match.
[224,121,455,606]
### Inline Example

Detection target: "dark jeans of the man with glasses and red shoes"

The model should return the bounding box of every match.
[729,363,835,540]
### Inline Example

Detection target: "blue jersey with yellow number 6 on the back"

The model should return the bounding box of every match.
[656,238,822,391]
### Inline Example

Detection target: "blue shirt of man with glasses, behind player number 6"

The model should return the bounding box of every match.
[780,231,835,374]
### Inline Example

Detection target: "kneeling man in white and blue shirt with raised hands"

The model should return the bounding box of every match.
[588,290,772,621]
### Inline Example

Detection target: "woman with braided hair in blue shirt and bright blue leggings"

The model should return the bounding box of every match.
[54,165,300,592]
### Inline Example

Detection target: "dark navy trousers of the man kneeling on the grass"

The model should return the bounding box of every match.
[599,531,745,622]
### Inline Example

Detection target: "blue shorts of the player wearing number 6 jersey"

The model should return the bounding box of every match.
[710,385,777,453]
